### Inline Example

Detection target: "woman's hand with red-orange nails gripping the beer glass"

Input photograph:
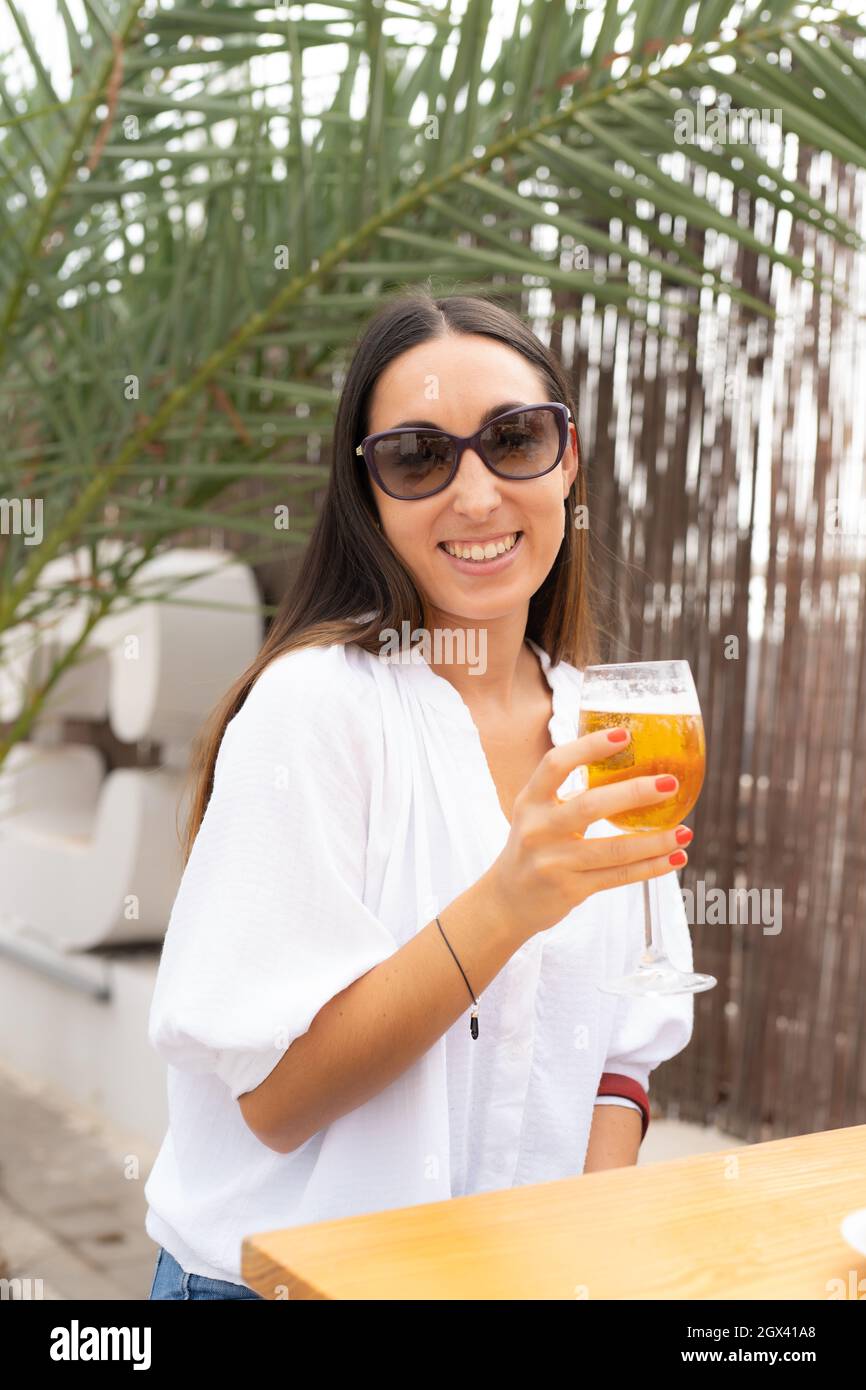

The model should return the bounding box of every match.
[491,728,695,937]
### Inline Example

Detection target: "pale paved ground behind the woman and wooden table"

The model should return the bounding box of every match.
[0,1063,738,1300]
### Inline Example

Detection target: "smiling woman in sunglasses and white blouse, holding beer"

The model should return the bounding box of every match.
[146,292,692,1298]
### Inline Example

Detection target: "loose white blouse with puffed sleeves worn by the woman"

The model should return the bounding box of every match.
[145,644,694,1283]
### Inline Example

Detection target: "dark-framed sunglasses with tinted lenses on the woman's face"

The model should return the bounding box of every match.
[354,400,571,502]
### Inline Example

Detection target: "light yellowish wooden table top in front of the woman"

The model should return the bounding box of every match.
[242,1125,866,1300]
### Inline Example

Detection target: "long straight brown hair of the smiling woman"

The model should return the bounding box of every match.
[183,288,598,862]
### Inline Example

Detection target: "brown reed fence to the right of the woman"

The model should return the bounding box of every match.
[552,154,866,1141]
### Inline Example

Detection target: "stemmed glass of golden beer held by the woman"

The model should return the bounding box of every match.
[578,662,719,994]
